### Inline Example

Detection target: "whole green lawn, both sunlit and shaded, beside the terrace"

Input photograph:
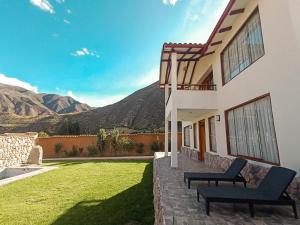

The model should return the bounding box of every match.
[0,161,154,225]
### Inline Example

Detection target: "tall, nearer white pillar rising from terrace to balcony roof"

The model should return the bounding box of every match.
[171,53,178,168]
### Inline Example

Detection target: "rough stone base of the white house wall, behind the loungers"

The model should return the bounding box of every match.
[204,152,300,200]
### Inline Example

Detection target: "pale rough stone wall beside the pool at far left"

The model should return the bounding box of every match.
[0,133,41,167]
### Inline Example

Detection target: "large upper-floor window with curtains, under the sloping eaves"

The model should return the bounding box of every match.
[221,9,264,85]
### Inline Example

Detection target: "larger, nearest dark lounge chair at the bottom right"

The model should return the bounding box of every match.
[197,167,298,219]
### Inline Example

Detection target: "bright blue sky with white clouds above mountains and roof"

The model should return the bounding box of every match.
[0,0,228,106]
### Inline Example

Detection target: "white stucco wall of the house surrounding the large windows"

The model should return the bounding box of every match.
[179,0,300,172]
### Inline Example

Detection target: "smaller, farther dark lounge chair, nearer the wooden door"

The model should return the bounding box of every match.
[183,158,247,188]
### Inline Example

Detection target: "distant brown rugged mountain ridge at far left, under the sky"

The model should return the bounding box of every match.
[0,84,91,117]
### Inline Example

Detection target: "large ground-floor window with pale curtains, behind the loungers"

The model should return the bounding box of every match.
[226,95,279,164]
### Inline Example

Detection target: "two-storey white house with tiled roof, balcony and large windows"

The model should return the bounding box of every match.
[160,0,300,172]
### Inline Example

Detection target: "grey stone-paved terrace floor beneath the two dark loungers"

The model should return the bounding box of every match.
[154,154,300,225]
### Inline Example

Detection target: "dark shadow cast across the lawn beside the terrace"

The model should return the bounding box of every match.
[52,161,154,225]
